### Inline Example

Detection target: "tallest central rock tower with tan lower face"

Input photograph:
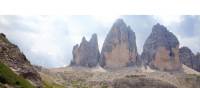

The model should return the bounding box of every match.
[100,19,138,68]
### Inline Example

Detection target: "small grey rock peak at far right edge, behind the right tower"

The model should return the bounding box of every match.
[179,47,200,71]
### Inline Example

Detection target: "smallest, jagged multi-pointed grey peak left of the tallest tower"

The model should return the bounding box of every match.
[71,34,100,67]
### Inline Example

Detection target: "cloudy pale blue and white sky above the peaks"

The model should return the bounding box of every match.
[0,15,200,67]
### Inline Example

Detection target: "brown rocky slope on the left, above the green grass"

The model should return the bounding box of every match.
[0,33,42,88]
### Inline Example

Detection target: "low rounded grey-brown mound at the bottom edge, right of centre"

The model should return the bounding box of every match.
[113,77,177,88]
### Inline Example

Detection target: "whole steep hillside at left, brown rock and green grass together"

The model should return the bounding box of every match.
[0,33,43,88]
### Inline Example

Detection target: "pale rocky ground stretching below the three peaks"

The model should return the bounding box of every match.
[37,65,200,88]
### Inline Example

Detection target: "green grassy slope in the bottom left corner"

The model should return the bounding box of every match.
[0,63,34,88]
